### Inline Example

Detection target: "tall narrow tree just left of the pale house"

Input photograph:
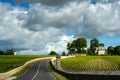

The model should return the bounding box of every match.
[90,38,99,54]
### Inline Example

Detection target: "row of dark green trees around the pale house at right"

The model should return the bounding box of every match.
[67,38,120,55]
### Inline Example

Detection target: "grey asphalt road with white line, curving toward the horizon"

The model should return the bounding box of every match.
[14,60,57,80]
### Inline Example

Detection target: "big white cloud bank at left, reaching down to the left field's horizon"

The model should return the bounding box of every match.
[0,3,74,54]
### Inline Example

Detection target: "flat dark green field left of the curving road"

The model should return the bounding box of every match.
[0,55,48,73]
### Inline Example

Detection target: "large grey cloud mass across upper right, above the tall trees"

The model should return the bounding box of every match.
[24,1,120,38]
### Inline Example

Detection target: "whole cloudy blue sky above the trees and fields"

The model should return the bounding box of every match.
[0,0,120,55]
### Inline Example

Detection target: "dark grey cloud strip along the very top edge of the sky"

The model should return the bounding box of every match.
[14,0,120,6]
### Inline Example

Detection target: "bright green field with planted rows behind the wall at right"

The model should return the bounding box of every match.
[61,56,120,72]
